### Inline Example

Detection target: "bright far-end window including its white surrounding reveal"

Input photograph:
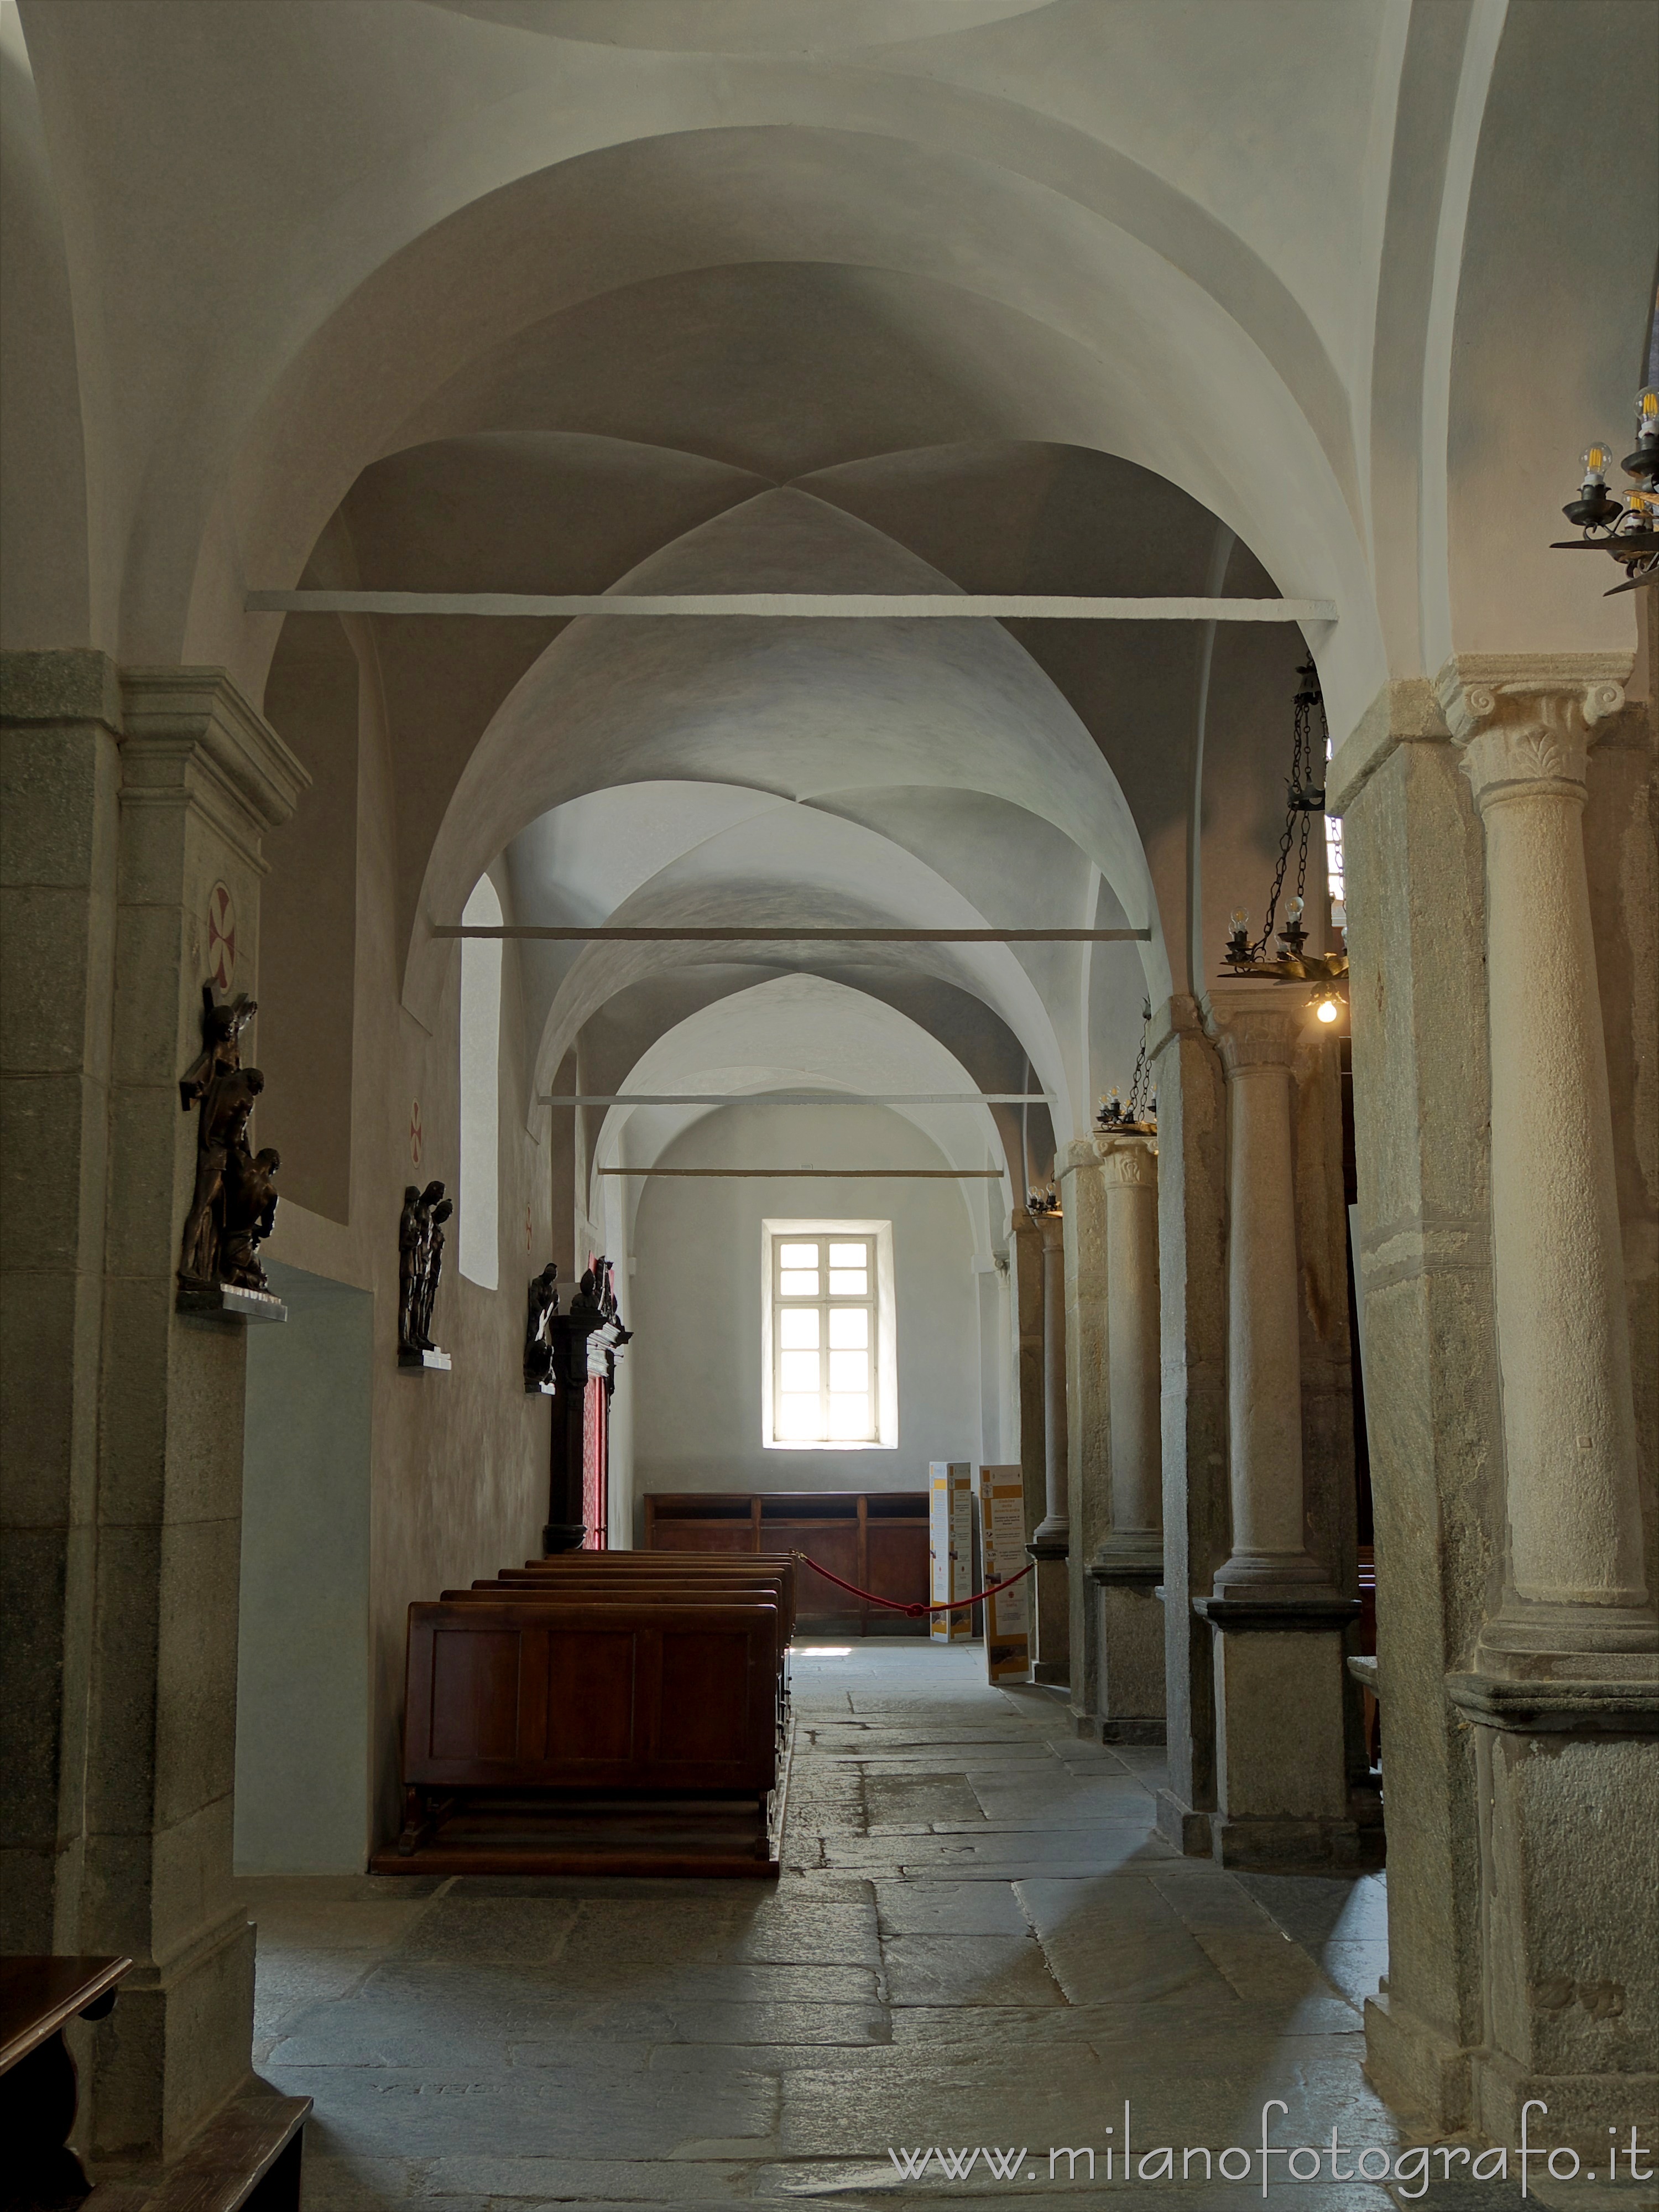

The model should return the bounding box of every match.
[763,1221,898,1451]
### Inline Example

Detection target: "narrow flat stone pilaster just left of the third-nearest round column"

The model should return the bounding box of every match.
[1055,1137,1110,1739]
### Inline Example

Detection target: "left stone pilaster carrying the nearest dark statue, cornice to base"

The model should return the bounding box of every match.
[90,668,307,2157]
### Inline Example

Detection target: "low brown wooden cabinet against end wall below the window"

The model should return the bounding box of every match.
[646,1491,927,1637]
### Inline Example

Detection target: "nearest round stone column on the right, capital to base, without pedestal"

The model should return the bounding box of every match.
[1440,655,1659,1677]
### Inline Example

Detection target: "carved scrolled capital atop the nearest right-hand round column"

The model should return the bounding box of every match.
[1436,653,1632,808]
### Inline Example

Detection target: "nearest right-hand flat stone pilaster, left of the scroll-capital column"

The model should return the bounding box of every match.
[1327,679,1502,2128]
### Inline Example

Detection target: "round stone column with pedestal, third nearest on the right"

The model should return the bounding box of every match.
[1088,1137,1164,1743]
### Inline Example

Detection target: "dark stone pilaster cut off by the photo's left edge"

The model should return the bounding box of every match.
[0,653,122,1951]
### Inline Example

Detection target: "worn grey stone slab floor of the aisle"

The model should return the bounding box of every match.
[243,1639,1416,2212]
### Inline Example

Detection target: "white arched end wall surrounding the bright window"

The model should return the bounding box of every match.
[628,1106,980,1522]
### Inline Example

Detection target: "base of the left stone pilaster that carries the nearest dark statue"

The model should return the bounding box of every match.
[91,1907,254,2163]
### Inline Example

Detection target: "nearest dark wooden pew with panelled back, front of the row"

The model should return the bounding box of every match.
[372,1586,783,1878]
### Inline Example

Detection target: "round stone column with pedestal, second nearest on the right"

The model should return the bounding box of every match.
[1194,991,1358,1867]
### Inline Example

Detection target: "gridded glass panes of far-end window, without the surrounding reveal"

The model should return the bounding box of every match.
[770,1234,880,1444]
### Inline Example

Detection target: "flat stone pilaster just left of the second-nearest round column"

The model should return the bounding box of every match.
[1148,996,1228,1851]
